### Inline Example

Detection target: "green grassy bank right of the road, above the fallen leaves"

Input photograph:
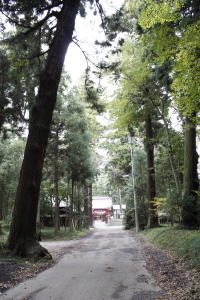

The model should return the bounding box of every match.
[141,227,200,269]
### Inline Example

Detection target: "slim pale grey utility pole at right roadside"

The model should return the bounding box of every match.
[128,137,139,233]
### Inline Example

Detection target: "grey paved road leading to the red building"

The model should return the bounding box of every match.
[0,226,161,300]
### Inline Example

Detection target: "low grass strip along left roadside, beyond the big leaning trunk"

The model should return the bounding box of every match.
[41,227,88,241]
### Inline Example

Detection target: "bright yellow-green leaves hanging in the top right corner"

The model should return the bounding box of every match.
[136,0,200,118]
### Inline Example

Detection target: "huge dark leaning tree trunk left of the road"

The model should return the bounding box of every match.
[8,0,80,257]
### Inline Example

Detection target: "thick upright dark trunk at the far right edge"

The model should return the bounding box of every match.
[182,118,199,228]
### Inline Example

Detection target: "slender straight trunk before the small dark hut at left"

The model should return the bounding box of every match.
[54,128,60,233]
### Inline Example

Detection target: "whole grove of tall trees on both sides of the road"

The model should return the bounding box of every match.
[0,0,200,259]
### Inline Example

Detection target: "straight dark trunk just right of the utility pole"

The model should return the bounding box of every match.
[145,115,158,228]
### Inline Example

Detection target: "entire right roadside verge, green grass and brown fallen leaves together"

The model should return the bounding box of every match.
[138,226,200,300]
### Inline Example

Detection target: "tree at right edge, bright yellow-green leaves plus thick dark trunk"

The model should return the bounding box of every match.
[134,0,200,228]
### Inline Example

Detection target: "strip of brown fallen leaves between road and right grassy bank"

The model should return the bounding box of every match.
[137,238,200,300]
